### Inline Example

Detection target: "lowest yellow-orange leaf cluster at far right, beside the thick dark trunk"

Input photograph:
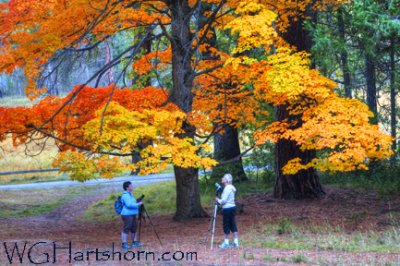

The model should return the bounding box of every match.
[281,96,392,174]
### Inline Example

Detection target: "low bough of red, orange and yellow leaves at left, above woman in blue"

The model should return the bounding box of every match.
[0,85,215,181]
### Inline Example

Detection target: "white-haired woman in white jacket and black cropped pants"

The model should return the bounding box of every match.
[216,174,239,248]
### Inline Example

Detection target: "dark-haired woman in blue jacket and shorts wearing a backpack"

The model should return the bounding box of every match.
[121,181,143,248]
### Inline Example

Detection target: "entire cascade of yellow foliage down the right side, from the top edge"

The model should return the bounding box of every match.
[227,1,391,190]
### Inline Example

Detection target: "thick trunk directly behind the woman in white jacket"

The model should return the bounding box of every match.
[211,125,247,182]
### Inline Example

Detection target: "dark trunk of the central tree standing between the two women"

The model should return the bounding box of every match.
[168,0,207,220]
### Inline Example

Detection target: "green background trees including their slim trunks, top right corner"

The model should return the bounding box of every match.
[310,1,400,166]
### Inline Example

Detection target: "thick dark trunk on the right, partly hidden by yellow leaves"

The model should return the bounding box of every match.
[274,9,325,199]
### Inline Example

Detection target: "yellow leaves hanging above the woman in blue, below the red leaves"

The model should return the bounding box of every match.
[56,101,216,177]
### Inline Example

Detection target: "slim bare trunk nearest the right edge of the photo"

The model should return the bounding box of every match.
[390,36,397,167]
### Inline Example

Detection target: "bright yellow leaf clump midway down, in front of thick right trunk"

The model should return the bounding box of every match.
[253,48,336,108]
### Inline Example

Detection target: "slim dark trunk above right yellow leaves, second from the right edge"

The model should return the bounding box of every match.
[365,52,378,124]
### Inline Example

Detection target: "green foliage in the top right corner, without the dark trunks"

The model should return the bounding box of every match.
[306,0,400,143]
